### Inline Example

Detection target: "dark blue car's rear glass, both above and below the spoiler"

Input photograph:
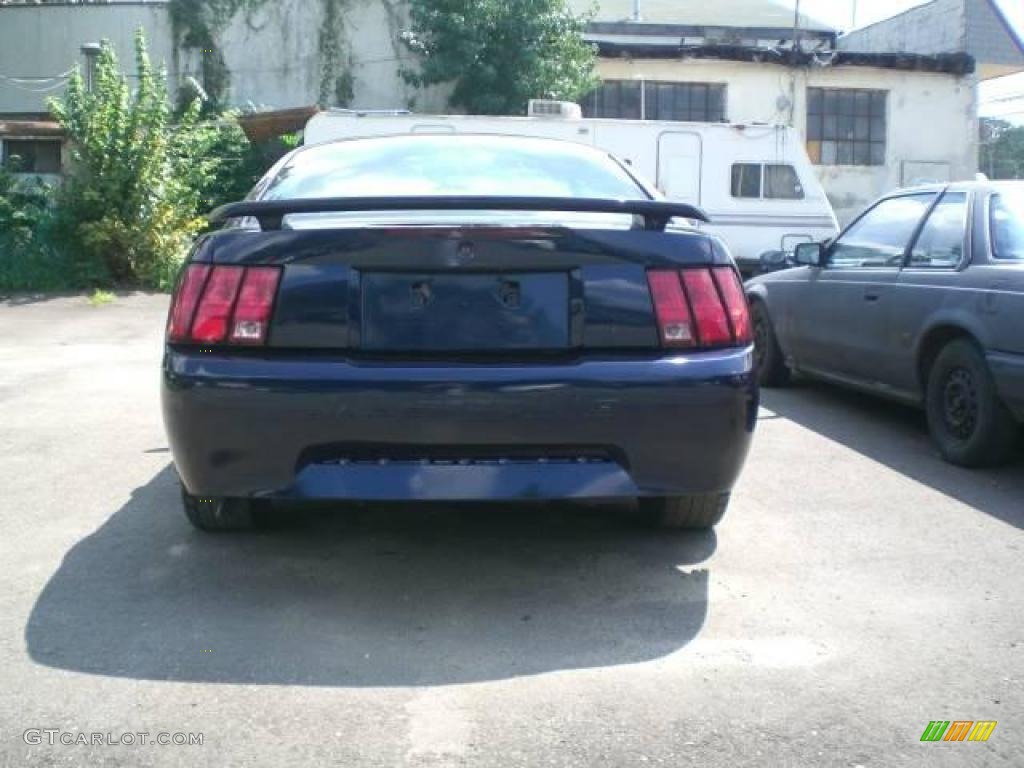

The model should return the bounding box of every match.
[258,134,650,229]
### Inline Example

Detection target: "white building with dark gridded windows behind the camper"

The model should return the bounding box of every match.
[572,0,1013,223]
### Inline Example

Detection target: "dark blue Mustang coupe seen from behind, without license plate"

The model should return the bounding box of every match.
[163,135,758,530]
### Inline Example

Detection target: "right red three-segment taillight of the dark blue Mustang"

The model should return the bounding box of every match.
[647,266,752,348]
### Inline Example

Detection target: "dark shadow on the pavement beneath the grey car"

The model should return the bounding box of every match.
[761,380,1024,528]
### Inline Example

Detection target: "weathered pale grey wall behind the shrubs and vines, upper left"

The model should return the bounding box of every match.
[0,0,445,115]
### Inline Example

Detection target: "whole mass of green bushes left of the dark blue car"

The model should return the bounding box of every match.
[0,31,298,290]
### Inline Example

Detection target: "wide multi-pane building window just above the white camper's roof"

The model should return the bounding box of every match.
[583,80,726,123]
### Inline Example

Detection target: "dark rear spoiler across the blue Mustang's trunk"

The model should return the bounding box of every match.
[209,196,710,230]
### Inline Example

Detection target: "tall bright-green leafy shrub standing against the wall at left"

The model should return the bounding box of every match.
[50,30,203,288]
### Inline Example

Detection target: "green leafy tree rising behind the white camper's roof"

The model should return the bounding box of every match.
[402,0,597,115]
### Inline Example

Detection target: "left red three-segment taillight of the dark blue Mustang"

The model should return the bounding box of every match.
[167,264,281,345]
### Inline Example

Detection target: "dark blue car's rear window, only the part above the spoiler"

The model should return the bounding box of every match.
[260,135,649,200]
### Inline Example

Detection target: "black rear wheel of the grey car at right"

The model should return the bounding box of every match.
[925,339,1017,467]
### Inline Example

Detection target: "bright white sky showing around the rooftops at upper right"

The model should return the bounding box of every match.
[800,0,1024,125]
